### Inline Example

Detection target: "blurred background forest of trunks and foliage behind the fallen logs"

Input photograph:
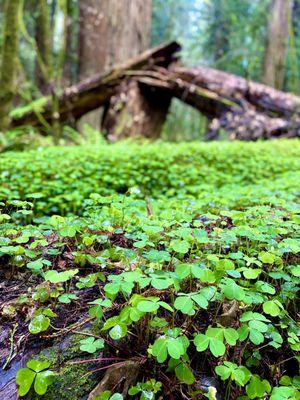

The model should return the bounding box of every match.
[0,0,300,145]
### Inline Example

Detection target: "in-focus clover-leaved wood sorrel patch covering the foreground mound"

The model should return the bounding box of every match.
[0,140,300,400]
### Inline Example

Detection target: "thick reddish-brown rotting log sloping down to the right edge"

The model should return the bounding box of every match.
[172,67,300,140]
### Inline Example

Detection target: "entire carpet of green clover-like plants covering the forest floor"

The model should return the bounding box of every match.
[0,140,300,400]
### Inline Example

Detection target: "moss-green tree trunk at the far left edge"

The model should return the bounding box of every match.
[0,0,21,131]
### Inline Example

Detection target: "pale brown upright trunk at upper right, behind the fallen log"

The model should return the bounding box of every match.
[262,0,293,89]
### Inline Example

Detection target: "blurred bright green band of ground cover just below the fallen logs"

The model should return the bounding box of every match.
[0,141,300,216]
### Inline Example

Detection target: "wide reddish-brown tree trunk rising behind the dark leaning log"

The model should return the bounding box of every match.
[79,0,151,134]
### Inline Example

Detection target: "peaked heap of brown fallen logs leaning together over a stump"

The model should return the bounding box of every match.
[13,42,300,140]
